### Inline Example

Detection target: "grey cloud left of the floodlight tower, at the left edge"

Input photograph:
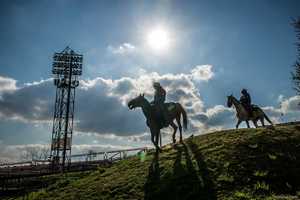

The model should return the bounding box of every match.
[0,79,55,121]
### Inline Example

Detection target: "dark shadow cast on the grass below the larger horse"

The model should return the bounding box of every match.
[144,142,216,200]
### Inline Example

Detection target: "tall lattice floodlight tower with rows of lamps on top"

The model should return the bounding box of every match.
[50,47,83,171]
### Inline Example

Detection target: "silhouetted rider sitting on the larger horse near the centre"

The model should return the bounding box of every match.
[153,82,169,126]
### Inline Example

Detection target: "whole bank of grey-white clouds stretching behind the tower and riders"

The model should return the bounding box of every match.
[0,65,300,140]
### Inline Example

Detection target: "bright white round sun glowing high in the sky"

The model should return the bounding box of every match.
[147,28,170,52]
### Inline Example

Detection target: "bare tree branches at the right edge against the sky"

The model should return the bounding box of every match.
[292,17,300,94]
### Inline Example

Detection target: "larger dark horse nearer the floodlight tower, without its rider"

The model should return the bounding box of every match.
[128,95,187,150]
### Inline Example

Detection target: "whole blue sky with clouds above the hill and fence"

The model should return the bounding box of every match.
[0,0,300,162]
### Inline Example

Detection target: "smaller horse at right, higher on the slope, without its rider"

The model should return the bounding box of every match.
[227,95,273,128]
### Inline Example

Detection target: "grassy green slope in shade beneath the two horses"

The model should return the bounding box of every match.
[17,125,300,200]
